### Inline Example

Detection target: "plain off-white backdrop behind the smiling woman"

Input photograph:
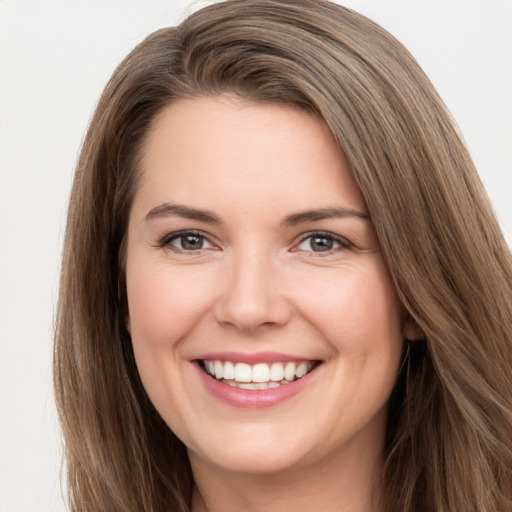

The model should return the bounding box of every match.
[0,0,512,512]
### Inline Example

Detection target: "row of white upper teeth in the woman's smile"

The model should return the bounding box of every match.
[204,360,313,382]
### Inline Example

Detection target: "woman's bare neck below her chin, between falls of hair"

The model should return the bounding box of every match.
[190,440,382,512]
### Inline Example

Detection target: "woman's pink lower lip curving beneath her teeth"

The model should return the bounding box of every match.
[195,362,320,409]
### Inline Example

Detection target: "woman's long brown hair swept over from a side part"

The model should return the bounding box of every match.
[54,0,512,512]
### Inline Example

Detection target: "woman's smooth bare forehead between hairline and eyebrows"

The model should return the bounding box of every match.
[134,96,364,219]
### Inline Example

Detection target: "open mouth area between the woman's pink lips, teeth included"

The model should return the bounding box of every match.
[199,359,321,390]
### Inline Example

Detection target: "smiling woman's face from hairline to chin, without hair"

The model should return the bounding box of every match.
[127,96,412,473]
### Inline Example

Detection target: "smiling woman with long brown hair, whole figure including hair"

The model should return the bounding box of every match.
[55,0,512,512]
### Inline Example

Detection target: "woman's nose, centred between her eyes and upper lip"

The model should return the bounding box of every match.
[214,254,292,334]
